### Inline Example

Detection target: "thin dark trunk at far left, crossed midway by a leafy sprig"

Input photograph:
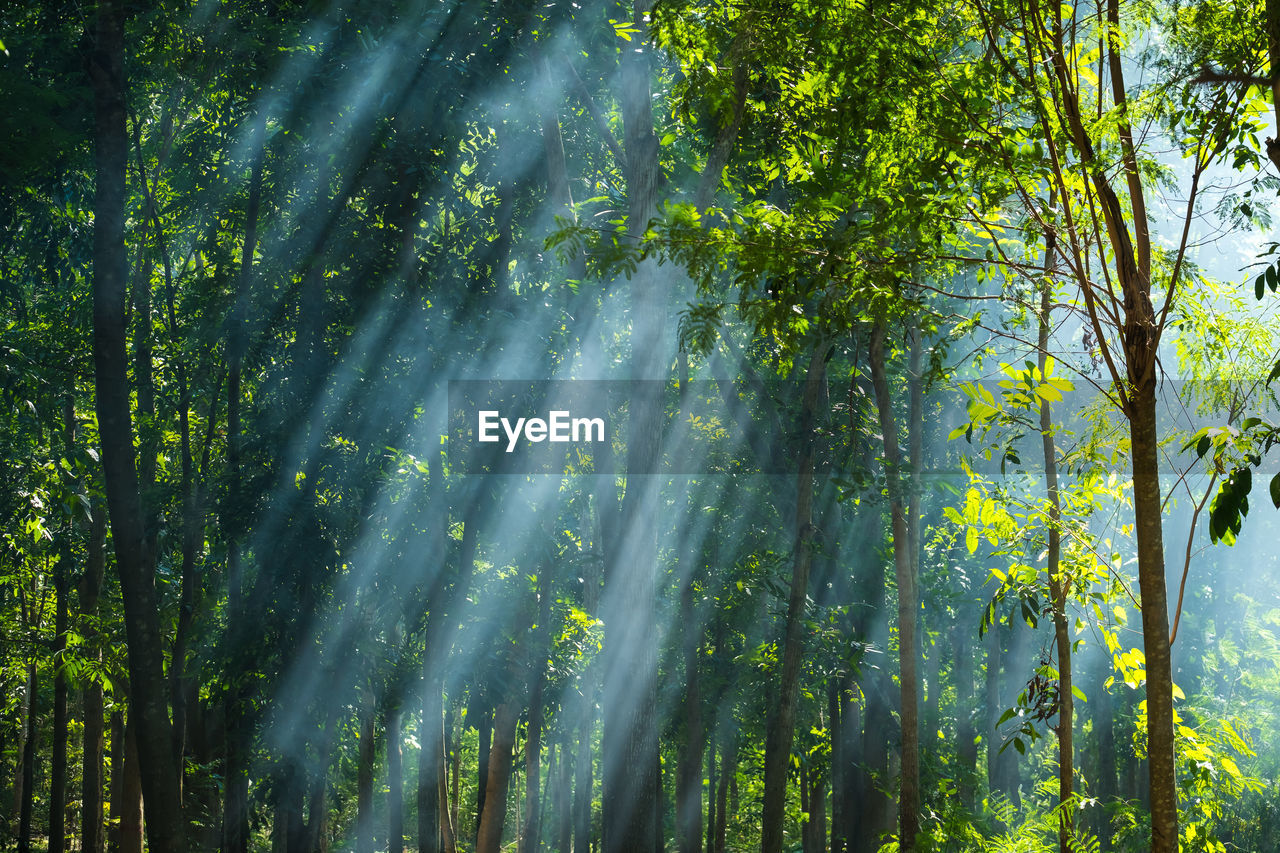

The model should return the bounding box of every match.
[79,507,106,853]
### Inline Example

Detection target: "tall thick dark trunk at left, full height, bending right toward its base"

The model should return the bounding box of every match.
[90,0,184,853]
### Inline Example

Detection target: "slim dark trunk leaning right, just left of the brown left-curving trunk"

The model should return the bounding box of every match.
[760,345,827,853]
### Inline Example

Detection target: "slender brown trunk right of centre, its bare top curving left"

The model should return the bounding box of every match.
[870,323,920,852]
